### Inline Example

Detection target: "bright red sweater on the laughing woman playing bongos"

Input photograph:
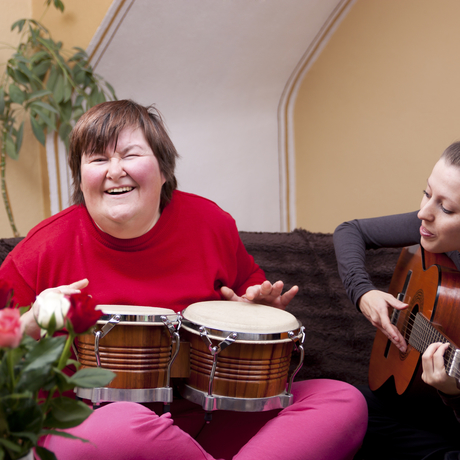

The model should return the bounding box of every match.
[0,191,265,311]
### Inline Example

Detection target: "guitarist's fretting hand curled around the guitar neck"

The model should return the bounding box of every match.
[422,343,460,395]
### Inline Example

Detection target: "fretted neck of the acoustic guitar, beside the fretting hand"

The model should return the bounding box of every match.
[409,312,460,379]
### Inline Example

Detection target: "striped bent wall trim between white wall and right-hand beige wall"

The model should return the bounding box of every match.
[278,0,356,231]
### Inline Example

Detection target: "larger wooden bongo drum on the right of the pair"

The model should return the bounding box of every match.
[180,301,305,412]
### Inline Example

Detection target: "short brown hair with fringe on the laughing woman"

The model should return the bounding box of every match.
[69,100,179,211]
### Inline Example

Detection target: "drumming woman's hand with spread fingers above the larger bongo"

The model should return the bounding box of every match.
[221,281,299,310]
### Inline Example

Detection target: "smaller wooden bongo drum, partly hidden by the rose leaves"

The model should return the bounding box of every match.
[76,305,180,404]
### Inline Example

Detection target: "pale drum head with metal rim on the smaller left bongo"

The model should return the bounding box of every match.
[96,305,177,326]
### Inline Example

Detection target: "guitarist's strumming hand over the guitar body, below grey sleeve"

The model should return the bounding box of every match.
[358,290,408,352]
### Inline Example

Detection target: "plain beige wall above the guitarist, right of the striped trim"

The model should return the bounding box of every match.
[295,0,460,232]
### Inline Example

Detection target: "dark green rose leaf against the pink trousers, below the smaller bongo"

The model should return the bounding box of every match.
[43,396,93,428]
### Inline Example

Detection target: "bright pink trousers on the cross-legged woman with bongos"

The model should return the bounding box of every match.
[42,379,367,460]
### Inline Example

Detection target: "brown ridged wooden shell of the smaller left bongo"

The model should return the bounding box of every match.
[77,323,172,389]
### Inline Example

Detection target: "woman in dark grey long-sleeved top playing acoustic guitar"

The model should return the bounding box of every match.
[334,142,460,460]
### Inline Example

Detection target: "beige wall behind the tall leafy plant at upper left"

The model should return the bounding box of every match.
[0,0,112,238]
